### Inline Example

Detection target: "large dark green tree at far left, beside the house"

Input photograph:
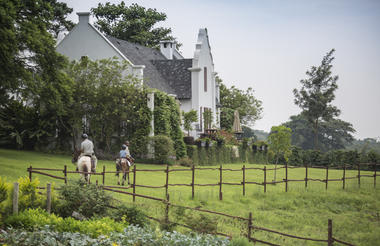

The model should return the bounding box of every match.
[0,0,71,146]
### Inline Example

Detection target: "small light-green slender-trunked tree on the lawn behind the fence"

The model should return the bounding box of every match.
[268,126,292,181]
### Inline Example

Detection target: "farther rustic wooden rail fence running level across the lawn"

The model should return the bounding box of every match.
[27,163,380,201]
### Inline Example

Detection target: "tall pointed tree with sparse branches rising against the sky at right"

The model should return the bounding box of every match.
[293,49,340,149]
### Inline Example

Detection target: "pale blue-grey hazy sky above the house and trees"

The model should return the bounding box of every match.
[61,0,380,139]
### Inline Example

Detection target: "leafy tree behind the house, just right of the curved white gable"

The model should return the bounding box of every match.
[216,76,263,130]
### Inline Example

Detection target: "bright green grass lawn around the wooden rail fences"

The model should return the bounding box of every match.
[0,149,380,245]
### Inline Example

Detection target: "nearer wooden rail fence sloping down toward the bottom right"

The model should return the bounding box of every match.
[13,183,353,246]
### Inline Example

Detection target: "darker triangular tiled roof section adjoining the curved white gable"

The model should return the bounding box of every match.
[152,59,193,99]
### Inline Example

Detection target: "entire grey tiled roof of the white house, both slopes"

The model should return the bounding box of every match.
[107,36,192,99]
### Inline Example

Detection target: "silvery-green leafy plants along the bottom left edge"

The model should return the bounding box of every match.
[0,226,229,246]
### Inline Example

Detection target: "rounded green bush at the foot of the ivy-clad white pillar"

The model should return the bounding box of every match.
[152,135,175,164]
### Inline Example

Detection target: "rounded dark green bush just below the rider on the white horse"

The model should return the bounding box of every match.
[54,180,112,218]
